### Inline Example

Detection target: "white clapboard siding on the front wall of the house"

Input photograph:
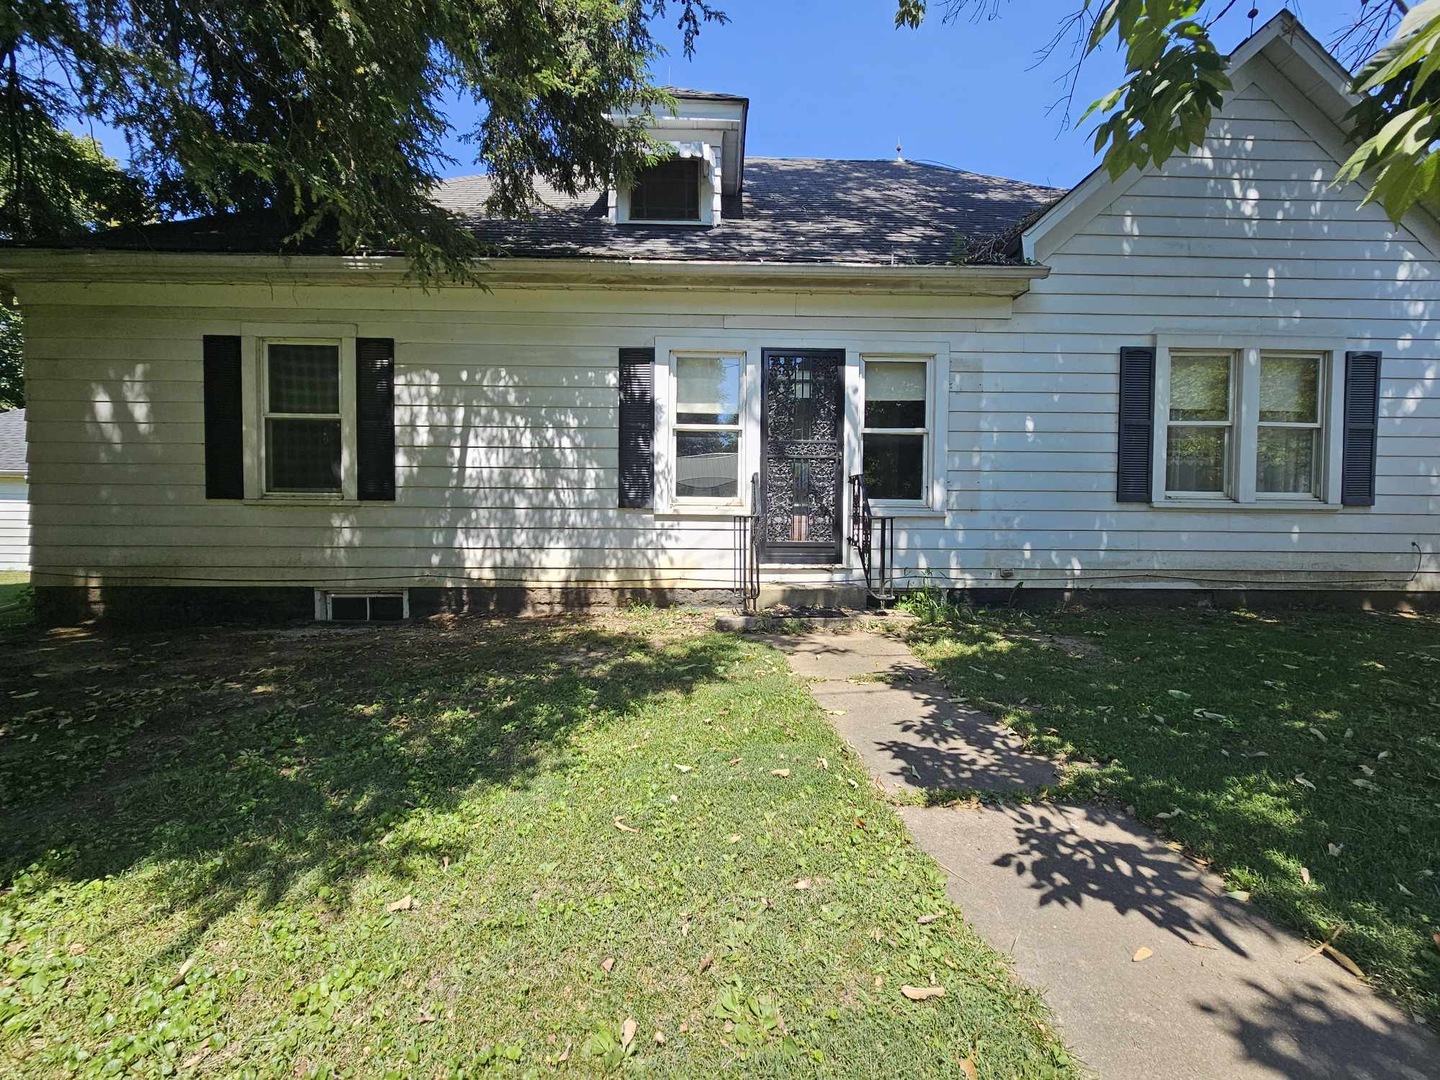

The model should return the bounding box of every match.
[14,59,1440,601]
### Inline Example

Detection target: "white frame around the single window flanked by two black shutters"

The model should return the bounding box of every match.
[240,323,358,505]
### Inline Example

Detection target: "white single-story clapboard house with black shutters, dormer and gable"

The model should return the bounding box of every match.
[0,14,1440,618]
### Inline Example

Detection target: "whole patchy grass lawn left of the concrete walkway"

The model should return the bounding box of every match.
[0,612,1076,1077]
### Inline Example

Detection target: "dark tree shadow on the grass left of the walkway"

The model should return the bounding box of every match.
[0,621,744,952]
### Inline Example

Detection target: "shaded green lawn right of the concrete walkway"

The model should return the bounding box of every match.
[914,609,1440,1020]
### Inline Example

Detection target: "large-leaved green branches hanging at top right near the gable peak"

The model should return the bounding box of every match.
[896,0,1440,222]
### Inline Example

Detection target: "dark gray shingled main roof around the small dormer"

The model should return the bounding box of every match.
[59,157,1064,265]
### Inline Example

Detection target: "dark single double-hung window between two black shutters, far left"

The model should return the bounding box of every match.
[261,341,344,495]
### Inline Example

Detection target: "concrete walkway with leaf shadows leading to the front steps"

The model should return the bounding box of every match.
[772,632,1440,1080]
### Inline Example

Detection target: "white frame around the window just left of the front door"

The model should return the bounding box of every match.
[654,340,760,517]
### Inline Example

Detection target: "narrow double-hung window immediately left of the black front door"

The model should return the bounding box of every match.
[670,353,744,503]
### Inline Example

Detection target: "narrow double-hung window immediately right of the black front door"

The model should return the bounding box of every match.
[861,357,930,503]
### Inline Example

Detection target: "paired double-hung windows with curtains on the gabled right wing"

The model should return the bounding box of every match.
[1156,347,1339,505]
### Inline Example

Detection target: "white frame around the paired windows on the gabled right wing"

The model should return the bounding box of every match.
[1151,334,1352,510]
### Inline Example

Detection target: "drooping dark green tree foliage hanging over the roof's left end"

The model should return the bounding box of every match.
[0,0,726,278]
